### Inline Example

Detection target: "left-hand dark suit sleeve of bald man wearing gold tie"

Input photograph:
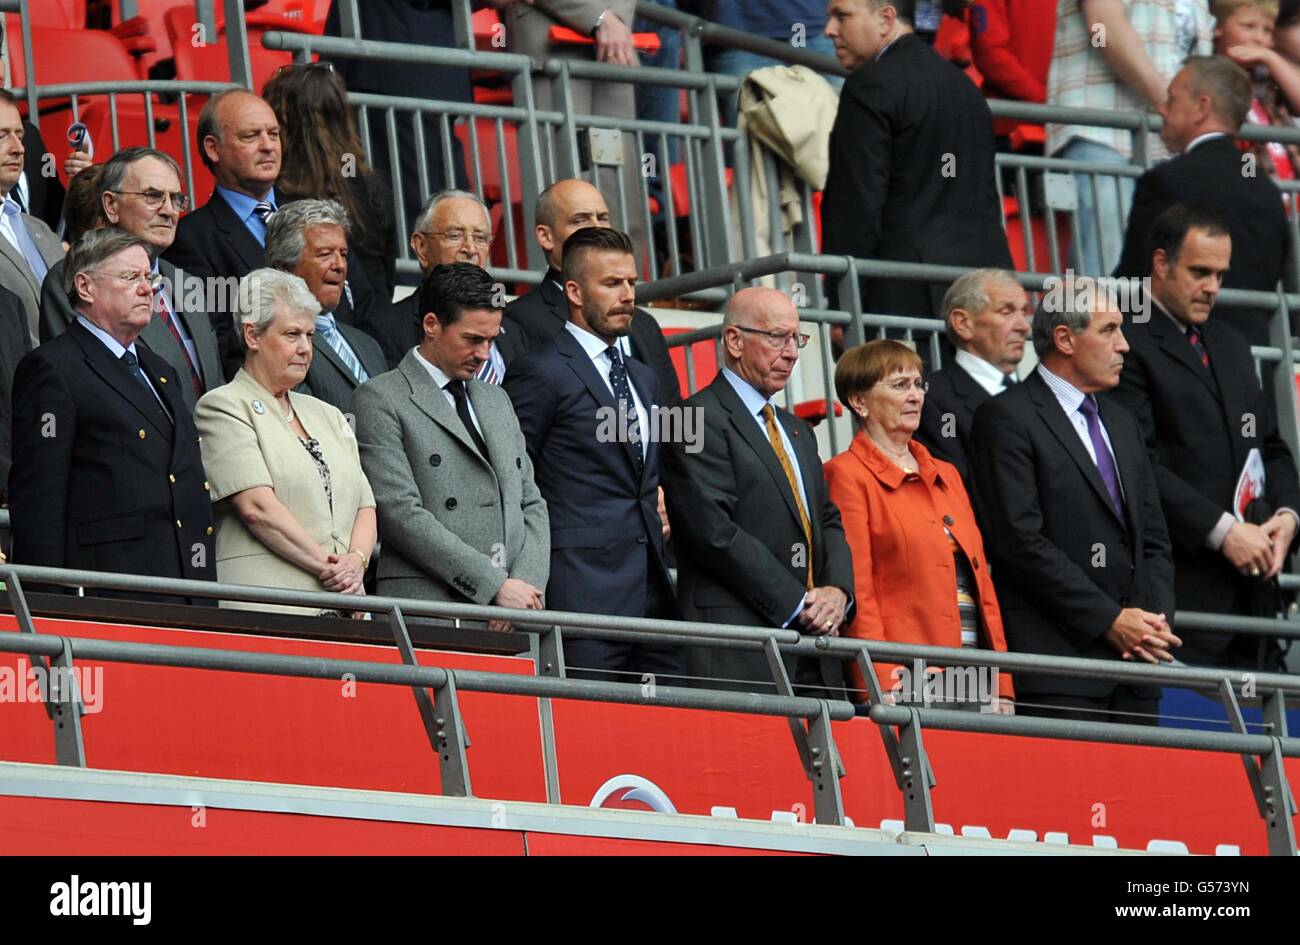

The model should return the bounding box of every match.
[663,409,806,620]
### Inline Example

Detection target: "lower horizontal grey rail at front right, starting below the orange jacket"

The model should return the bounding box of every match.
[868,701,1300,758]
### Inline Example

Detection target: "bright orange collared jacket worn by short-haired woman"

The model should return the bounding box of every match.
[826,433,1014,698]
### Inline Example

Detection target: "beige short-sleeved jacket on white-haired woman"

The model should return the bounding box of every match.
[194,368,374,612]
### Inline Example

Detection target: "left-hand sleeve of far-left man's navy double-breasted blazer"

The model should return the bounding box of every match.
[9,352,77,568]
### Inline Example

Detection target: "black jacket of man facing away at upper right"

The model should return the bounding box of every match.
[1115,135,1288,344]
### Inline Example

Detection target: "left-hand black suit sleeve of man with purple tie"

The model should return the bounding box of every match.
[971,398,1128,649]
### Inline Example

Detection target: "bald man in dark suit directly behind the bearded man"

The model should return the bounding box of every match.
[506,178,681,404]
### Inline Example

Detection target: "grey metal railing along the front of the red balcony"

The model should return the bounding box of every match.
[0,564,1300,855]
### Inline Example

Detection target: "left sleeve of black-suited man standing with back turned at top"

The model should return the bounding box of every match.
[822,77,893,259]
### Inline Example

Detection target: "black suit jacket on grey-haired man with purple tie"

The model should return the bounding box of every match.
[970,370,1174,698]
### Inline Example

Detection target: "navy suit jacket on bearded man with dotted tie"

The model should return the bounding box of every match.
[503,331,672,617]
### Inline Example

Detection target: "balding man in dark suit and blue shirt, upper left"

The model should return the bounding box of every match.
[164,88,373,377]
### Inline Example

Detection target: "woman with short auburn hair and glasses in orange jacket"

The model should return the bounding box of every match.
[826,339,1014,715]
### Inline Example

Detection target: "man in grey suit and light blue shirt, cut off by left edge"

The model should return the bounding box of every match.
[0,88,64,344]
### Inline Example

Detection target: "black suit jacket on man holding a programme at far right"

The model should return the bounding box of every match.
[1108,304,1300,668]
